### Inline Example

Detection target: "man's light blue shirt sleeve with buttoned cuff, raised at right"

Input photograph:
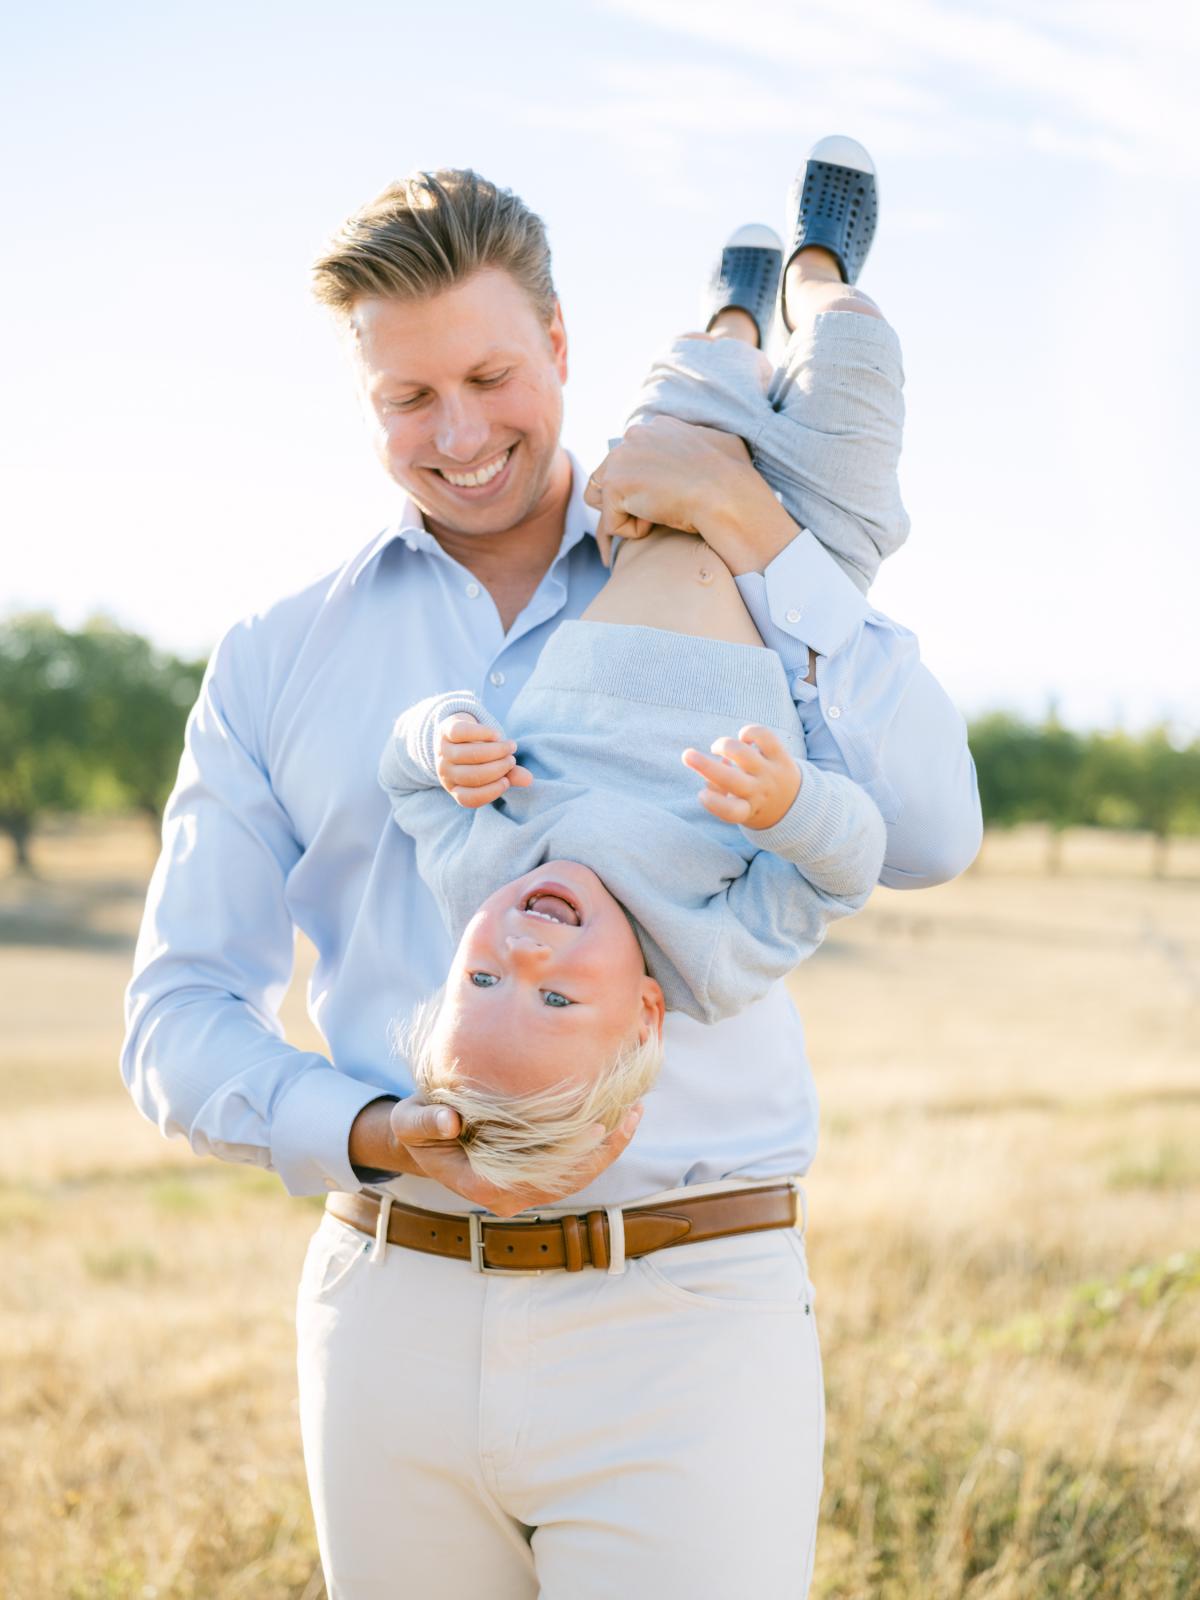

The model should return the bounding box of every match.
[738,530,982,888]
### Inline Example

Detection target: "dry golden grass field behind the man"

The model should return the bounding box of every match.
[0,824,1200,1600]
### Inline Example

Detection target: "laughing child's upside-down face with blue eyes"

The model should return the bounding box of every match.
[437,861,662,1094]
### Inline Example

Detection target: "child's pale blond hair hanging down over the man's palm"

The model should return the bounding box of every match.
[394,986,662,1194]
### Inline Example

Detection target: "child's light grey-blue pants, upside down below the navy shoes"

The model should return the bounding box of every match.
[627,310,909,594]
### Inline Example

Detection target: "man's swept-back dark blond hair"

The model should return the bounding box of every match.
[312,168,555,325]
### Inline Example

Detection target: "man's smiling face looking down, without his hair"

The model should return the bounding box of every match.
[350,267,566,534]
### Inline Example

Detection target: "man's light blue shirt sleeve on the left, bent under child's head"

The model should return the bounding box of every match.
[120,624,381,1195]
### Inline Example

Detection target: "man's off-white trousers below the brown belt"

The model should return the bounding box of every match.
[296,1190,824,1600]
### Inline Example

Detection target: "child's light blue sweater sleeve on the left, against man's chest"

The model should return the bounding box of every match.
[379,690,499,920]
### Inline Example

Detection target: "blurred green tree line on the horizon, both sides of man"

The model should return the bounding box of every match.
[0,613,1200,872]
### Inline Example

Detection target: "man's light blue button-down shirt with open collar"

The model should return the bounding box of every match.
[122,462,979,1208]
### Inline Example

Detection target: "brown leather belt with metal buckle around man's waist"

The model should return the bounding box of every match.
[325,1182,797,1272]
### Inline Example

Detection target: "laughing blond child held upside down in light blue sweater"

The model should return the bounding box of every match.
[379,141,906,1190]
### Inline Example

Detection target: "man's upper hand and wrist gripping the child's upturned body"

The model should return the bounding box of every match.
[584,416,800,576]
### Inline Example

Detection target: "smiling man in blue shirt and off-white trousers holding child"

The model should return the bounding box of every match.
[122,171,979,1600]
